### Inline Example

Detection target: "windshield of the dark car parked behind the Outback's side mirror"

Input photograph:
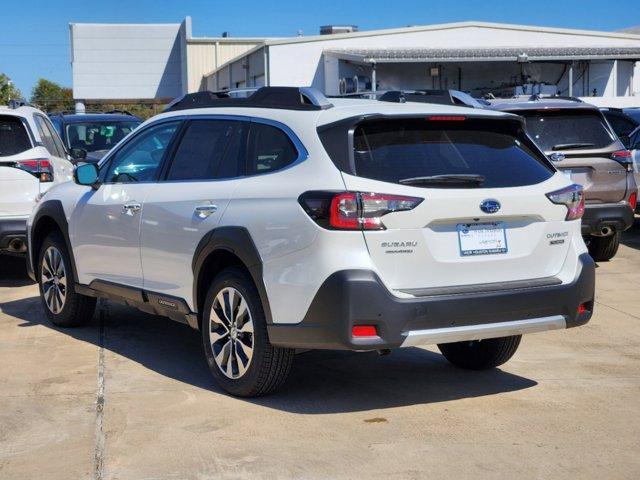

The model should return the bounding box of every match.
[66,121,140,152]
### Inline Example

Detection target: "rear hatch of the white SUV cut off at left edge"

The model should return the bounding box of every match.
[0,115,41,217]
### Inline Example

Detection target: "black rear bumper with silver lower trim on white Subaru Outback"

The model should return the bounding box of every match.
[268,254,595,350]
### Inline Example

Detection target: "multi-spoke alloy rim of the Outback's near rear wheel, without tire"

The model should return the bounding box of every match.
[209,287,254,380]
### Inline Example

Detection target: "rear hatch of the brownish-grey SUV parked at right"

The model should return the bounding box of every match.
[518,108,627,204]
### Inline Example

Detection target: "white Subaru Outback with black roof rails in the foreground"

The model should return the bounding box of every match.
[29,87,594,396]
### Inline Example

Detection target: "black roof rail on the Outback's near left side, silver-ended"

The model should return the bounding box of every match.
[164,87,333,112]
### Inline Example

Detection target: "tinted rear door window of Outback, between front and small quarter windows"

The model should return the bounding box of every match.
[167,120,244,181]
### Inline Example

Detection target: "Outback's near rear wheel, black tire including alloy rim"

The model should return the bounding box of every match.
[201,267,295,397]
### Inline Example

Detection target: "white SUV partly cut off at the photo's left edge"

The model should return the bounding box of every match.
[0,106,73,254]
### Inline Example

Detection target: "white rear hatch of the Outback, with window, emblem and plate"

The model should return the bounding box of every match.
[321,116,571,295]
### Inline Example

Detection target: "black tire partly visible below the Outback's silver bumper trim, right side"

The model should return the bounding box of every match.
[438,335,522,370]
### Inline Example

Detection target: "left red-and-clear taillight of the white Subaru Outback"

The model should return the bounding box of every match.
[298,191,424,230]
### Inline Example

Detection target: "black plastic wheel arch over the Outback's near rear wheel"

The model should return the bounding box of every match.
[192,227,273,324]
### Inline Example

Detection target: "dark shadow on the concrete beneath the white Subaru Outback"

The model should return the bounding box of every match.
[0,296,536,415]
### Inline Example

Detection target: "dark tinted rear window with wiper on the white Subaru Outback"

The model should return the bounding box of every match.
[353,119,554,188]
